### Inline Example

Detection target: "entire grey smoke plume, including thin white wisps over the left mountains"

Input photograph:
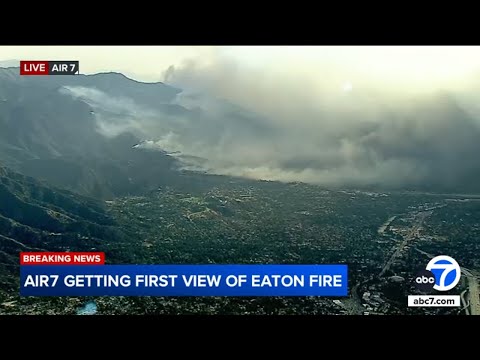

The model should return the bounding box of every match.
[61,52,480,190]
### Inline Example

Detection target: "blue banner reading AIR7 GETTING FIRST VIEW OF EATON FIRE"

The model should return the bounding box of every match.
[20,265,348,296]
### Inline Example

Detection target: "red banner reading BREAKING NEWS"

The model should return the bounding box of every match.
[20,252,105,265]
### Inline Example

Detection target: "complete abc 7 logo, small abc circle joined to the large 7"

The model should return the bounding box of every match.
[414,255,461,292]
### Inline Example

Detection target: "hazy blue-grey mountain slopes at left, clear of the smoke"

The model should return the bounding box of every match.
[0,68,195,198]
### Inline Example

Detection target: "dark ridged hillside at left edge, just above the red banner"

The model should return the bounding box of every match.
[0,167,135,301]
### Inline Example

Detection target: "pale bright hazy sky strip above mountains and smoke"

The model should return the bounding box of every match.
[0,46,480,90]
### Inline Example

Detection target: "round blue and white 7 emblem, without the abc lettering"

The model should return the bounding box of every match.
[426,255,462,291]
